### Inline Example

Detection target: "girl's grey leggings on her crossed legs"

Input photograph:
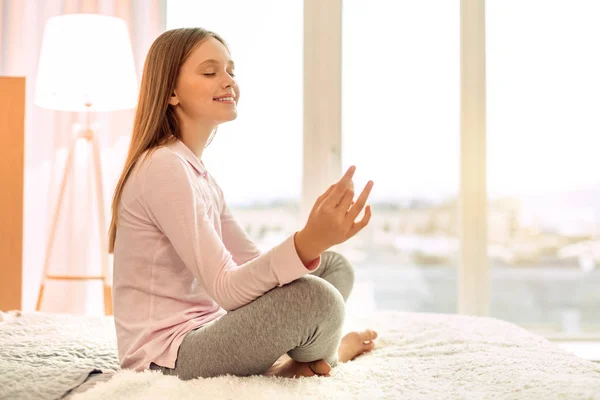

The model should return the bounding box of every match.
[150,251,354,380]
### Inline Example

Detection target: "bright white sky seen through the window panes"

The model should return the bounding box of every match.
[167,0,600,203]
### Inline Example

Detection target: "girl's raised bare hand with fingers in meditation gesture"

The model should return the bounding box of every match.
[297,166,373,256]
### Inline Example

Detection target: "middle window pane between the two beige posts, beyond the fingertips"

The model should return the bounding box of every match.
[341,0,460,312]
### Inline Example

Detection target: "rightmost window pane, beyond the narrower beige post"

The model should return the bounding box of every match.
[486,0,600,333]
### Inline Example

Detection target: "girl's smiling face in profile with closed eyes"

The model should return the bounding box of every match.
[169,37,240,126]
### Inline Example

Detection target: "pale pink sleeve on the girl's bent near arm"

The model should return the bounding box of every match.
[138,152,320,311]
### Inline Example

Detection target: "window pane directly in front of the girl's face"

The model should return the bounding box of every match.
[167,0,303,250]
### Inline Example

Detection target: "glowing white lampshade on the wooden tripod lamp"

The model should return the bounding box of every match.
[35,14,137,111]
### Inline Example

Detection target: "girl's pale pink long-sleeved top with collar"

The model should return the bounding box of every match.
[113,140,321,371]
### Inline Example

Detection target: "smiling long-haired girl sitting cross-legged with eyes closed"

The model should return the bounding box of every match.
[109,28,376,380]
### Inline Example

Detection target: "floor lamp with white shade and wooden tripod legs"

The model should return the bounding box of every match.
[35,14,138,315]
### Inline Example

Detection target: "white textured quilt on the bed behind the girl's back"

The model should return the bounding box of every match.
[0,312,119,400]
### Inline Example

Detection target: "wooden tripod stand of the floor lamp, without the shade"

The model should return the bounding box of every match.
[35,103,112,315]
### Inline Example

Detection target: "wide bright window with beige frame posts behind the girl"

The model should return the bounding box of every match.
[167,0,600,335]
